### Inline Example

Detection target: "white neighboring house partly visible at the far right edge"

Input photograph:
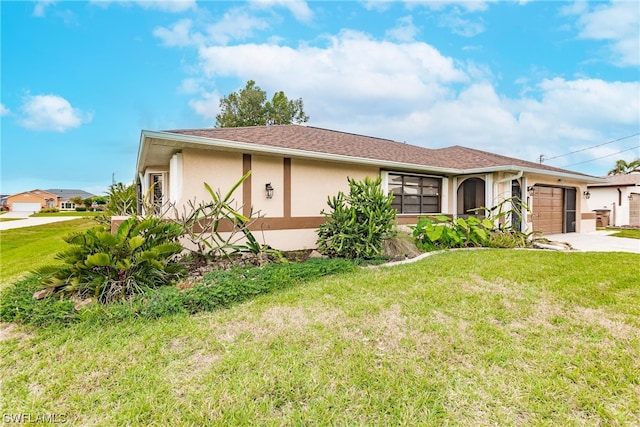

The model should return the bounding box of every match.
[587,173,640,227]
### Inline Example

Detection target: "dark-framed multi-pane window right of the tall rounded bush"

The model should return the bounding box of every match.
[389,174,442,214]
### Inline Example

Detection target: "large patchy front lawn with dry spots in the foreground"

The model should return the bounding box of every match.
[0,250,640,426]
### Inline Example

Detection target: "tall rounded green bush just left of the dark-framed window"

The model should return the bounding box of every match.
[317,177,396,259]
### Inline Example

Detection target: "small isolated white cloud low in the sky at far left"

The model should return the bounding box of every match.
[19,95,93,132]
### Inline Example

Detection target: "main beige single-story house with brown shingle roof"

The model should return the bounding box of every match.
[136,125,602,250]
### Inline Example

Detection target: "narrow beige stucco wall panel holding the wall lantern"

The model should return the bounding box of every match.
[251,155,284,218]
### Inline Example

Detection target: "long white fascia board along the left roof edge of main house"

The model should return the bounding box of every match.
[138,130,464,175]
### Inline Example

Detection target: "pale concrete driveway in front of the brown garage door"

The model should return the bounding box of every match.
[543,230,640,254]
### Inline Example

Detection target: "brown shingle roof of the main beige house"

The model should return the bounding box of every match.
[164,125,589,177]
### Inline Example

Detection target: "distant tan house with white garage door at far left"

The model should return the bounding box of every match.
[7,189,95,212]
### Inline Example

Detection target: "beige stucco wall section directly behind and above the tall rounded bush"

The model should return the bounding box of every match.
[291,159,380,217]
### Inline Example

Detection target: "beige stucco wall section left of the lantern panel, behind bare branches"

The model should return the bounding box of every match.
[178,148,243,208]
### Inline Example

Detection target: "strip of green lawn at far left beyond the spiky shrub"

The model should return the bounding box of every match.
[0,218,97,289]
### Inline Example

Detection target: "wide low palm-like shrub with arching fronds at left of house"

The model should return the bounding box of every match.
[36,217,185,303]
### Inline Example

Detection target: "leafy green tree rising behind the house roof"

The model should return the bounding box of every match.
[215,80,309,128]
